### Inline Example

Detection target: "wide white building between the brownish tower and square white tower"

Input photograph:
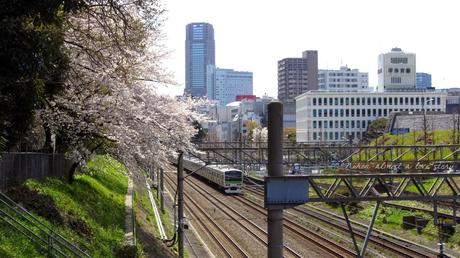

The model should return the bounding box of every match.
[318,66,369,91]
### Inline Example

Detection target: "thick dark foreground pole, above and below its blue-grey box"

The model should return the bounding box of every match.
[267,101,284,258]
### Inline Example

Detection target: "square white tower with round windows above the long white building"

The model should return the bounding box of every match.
[377,48,416,92]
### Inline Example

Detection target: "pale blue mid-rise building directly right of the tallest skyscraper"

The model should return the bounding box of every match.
[207,65,253,105]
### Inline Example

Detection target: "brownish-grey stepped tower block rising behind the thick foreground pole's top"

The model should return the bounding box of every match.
[278,50,318,127]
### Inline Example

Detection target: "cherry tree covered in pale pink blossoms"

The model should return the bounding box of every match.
[40,0,203,173]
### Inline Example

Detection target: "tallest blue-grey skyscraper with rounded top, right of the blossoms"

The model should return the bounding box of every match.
[185,23,215,97]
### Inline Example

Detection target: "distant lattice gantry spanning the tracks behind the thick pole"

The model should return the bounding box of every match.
[193,142,460,171]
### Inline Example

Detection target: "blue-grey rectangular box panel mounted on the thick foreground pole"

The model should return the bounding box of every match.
[265,176,309,208]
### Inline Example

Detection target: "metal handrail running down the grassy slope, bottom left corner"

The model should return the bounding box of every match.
[0,191,91,257]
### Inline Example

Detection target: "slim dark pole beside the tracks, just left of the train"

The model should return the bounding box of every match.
[177,151,184,258]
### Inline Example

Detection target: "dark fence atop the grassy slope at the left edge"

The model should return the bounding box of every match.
[0,152,72,190]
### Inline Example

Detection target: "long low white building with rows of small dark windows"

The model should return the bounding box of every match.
[296,91,447,142]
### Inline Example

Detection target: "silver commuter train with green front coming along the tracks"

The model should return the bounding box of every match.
[183,158,243,194]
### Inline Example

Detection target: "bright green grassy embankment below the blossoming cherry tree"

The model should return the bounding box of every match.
[0,156,127,257]
